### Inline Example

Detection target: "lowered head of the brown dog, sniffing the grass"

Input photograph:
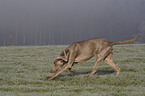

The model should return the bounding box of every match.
[50,58,67,73]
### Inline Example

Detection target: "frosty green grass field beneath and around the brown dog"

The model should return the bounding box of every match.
[0,45,145,96]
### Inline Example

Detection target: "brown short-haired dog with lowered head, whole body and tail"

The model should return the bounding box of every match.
[46,36,140,80]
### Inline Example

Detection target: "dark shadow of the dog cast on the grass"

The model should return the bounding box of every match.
[56,70,115,78]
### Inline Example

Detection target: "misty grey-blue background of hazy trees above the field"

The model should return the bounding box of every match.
[0,0,145,46]
